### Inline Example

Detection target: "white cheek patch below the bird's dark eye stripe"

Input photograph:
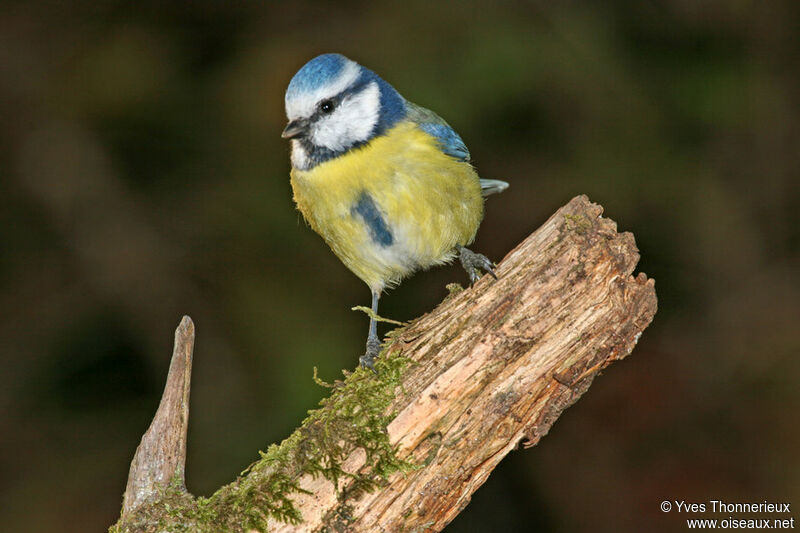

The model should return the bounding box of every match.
[311,82,381,152]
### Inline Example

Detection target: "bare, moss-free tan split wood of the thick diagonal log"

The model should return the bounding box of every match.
[275,196,656,532]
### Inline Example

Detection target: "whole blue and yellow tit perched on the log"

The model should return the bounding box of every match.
[281,53,508,371]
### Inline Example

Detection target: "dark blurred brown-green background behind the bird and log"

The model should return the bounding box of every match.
[0,0,800,533]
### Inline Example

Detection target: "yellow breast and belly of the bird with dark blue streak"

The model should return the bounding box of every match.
[291,122,483,291]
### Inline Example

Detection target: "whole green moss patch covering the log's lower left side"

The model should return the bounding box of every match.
[110,351,416,533]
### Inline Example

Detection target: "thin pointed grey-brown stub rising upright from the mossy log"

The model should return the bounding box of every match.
[122,316,194,516]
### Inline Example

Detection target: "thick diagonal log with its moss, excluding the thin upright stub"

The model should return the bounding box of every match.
[112,196,656,532]
